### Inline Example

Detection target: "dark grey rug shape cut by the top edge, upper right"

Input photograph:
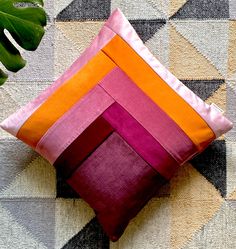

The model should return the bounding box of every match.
[170,0,229,19]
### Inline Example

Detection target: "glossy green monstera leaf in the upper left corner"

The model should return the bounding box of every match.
[0,0,46,85]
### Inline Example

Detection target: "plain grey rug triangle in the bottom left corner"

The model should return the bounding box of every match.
[1,198,55,248]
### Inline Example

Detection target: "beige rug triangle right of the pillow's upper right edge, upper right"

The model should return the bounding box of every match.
[169,25,222,79]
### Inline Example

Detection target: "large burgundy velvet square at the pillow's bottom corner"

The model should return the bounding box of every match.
[67,132,166,241]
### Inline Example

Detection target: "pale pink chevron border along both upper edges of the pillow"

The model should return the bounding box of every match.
[1,9,233,140]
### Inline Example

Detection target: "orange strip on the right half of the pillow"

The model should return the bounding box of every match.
[102,35,215,151]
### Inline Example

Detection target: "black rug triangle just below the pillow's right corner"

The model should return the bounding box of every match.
[190,140,226,197]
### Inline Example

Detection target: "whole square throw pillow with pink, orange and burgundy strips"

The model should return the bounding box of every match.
[1,9,232,241]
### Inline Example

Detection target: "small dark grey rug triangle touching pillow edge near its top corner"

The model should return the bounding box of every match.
[129,19,166,42]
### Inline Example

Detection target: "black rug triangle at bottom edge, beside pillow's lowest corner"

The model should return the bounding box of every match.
[62,217,109,249]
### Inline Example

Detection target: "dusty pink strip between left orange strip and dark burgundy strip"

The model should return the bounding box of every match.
[36,85,114,164]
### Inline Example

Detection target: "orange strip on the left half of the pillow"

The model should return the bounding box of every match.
[17,51,116,148]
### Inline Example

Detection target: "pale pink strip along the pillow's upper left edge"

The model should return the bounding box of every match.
[1,26,115,136]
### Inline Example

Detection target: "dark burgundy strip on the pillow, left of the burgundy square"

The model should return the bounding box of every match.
[54,116,113,178]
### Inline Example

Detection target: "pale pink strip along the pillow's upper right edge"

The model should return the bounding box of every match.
[105,9,233,137]
